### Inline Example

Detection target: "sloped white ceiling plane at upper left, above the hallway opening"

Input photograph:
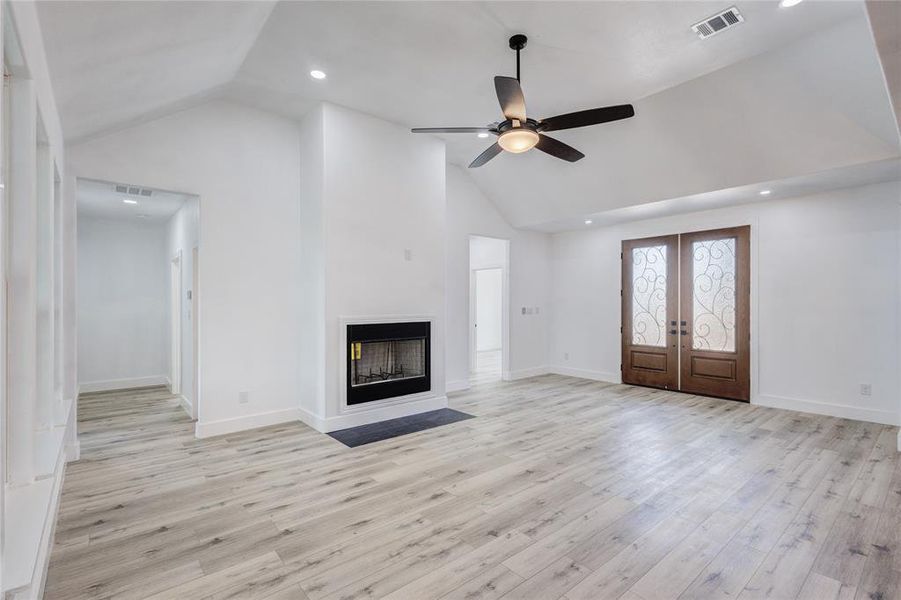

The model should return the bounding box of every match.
[37,1,274,141]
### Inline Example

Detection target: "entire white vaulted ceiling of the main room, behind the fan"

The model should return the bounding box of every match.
[39,0,901,228]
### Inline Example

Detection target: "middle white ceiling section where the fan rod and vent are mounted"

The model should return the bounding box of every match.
[231,1,861,159]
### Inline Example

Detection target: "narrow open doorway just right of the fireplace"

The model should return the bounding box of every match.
[469,236,509,384]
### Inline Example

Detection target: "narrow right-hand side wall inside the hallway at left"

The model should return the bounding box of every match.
[166,197,200,407]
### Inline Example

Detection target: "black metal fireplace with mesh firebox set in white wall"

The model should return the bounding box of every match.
[346,321,432,406]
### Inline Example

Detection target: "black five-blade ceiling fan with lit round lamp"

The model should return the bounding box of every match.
[412,33,635,169]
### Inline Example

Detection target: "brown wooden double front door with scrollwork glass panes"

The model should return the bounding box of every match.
[622,226,751,402]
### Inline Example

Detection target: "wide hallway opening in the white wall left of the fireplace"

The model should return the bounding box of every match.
[76,178,200,418]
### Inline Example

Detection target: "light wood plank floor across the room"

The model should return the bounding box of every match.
[46,375,901,600]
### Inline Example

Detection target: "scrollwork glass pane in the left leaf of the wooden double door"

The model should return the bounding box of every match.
[632,246,666,346]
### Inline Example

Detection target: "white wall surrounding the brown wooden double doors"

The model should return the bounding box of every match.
[550,183,901,423]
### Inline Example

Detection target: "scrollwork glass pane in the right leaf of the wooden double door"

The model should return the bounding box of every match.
[692,238,735,352]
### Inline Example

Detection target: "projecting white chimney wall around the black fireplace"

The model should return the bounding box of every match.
[299,104,447,430]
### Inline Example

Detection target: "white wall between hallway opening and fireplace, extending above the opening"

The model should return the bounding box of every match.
[69,101,304,436]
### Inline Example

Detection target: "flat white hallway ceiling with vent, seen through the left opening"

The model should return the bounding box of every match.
[76,179,192,224]
